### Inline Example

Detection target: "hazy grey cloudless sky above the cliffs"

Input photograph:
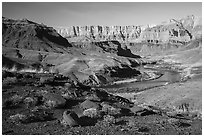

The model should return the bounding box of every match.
[2,2,202,27]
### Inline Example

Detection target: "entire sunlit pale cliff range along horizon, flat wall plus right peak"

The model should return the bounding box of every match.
[55,16,202,44]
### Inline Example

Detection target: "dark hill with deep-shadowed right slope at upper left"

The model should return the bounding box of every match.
[2,17,71,53]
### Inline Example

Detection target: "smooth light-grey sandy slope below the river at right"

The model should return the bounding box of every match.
[117,78,202,115]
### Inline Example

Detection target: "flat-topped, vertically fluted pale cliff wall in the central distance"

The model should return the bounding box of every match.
[55,26,142,41]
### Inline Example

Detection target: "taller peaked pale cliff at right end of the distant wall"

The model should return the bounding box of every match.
[140,16,202,44]
